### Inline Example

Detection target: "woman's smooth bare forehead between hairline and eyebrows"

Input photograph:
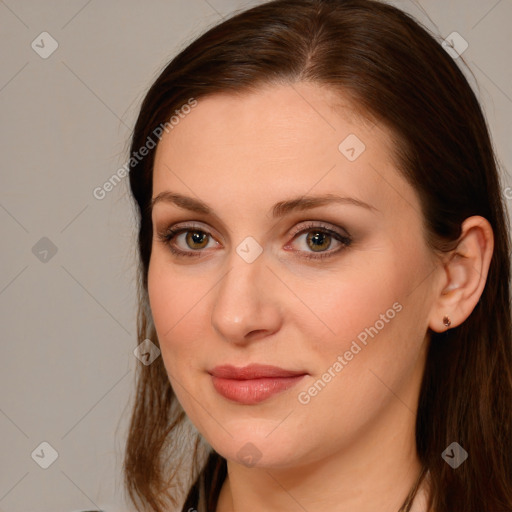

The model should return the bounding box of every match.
[153,83,414,219]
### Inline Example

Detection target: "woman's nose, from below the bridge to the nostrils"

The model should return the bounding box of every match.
[211,251,284,346]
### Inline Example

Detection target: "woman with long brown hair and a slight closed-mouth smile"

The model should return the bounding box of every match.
[125,0,512,512]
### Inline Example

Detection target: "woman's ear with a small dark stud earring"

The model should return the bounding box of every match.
[429,216,494,332]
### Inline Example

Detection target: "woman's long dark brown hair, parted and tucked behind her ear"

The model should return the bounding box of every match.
[124,0,512,512]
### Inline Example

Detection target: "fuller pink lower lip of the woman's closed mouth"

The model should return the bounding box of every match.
[212,375,305,405]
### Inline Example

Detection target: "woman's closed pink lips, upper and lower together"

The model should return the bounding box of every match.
[209,364,307,405]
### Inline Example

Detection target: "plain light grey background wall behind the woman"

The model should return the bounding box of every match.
[0,0,512,512]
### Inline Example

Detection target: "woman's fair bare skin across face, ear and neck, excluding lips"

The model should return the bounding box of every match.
[148,83,493,512]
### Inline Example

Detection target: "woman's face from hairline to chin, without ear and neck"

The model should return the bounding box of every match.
[148,83,438,468]
